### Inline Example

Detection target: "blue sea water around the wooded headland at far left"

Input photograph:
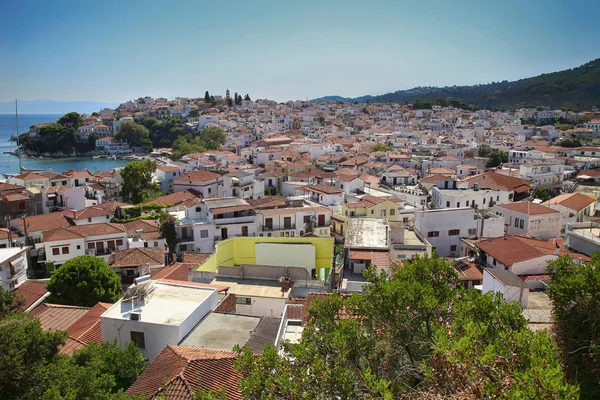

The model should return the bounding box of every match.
[0,114,127,178]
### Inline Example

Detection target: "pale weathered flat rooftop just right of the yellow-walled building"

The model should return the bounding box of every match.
[344,218,388,249]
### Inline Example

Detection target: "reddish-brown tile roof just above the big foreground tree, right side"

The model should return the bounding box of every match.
[474,236,547,267]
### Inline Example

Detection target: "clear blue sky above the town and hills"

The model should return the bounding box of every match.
[0,0,600,102]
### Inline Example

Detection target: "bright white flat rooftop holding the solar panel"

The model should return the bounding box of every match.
[102,281,217,326]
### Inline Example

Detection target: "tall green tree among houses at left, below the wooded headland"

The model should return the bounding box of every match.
[120,159,159,204]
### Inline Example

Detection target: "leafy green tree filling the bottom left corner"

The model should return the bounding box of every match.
[0,313,67,399]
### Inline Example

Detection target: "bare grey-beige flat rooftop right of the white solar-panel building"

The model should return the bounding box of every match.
[179,312,260,351]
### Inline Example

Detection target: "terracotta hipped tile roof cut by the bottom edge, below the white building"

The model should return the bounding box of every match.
[126,345,242,400]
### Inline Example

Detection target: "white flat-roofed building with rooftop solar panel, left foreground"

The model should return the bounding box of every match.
[100,279,219,361]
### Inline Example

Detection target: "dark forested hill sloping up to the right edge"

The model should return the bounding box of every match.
[313,58,600,110]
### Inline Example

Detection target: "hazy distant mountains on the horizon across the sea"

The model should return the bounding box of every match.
[0,100,119,114]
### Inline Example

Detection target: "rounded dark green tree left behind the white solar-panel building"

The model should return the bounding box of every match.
[46,255,122,307]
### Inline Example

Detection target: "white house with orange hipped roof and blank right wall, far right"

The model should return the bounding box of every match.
[494,201,563,240]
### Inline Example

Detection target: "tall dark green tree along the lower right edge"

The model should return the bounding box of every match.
[546,253,600,399]
